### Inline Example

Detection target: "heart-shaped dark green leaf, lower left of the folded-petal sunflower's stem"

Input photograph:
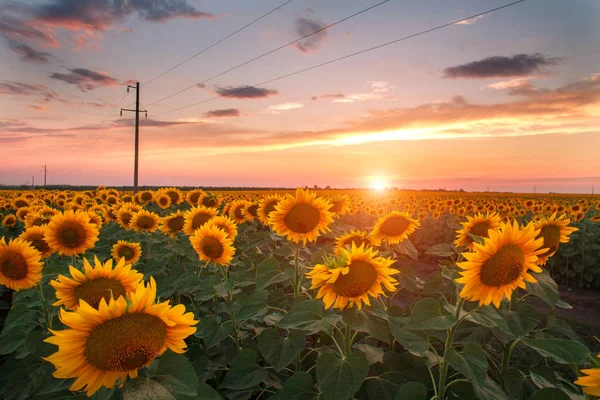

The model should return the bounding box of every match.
[258,329,306,372]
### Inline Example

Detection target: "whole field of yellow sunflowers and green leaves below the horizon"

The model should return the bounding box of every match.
[0,187,600,400]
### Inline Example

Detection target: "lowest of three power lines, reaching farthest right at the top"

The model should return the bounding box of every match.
[155,0,525,117]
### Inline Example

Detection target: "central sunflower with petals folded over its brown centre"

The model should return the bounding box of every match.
[306,243,398,309]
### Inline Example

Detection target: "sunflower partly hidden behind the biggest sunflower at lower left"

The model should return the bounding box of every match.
[50,257,144,310]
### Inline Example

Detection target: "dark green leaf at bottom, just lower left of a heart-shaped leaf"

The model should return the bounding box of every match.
[219,349,267,390]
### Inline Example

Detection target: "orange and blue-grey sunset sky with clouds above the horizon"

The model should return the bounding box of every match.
[0,0,600,193]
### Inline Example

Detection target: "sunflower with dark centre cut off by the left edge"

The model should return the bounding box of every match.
[0,238,43,292]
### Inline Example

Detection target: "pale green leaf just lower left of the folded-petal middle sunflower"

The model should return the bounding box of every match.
[277,300,342,335]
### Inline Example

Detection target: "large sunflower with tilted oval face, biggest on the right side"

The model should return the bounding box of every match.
[456,221,545,308]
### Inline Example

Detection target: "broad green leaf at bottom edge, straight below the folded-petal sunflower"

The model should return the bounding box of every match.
[317,350,369,400]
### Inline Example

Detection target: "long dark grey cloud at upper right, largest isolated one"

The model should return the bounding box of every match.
[444,53,561,79]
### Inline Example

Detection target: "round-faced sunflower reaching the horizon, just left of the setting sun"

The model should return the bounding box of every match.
[269,188,333,245]
